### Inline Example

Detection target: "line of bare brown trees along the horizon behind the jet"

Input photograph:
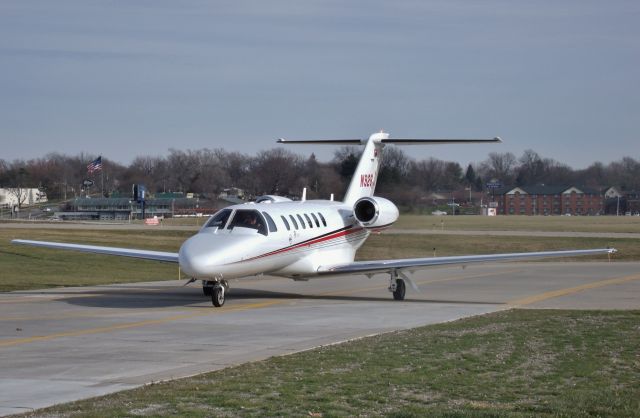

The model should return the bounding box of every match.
[0,146,640,206]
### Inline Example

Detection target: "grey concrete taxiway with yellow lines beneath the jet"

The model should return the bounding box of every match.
[0,262,640,415]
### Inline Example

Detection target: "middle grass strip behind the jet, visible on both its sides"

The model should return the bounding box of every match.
[0,228,640,292]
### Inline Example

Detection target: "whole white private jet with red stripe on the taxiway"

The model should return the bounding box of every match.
[12,132,615,307]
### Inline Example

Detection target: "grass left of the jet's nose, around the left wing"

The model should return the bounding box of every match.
[0,229,191,292]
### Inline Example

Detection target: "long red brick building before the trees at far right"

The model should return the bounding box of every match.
[496,186,604,215]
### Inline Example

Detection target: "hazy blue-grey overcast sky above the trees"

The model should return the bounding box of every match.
[0,0,640,168]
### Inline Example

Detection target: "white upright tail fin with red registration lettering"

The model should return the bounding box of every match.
[343,132,389,205]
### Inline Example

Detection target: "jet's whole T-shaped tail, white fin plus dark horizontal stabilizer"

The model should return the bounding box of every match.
[278,132,502,205]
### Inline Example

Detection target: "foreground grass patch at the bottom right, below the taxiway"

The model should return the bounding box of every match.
[17,310,640,417]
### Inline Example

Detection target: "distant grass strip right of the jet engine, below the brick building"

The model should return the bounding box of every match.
[394,214,640,233]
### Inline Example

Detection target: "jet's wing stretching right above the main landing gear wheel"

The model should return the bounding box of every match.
[318,248,616,275]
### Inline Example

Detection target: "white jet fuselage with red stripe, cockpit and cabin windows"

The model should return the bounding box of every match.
[179,200,370,280]
